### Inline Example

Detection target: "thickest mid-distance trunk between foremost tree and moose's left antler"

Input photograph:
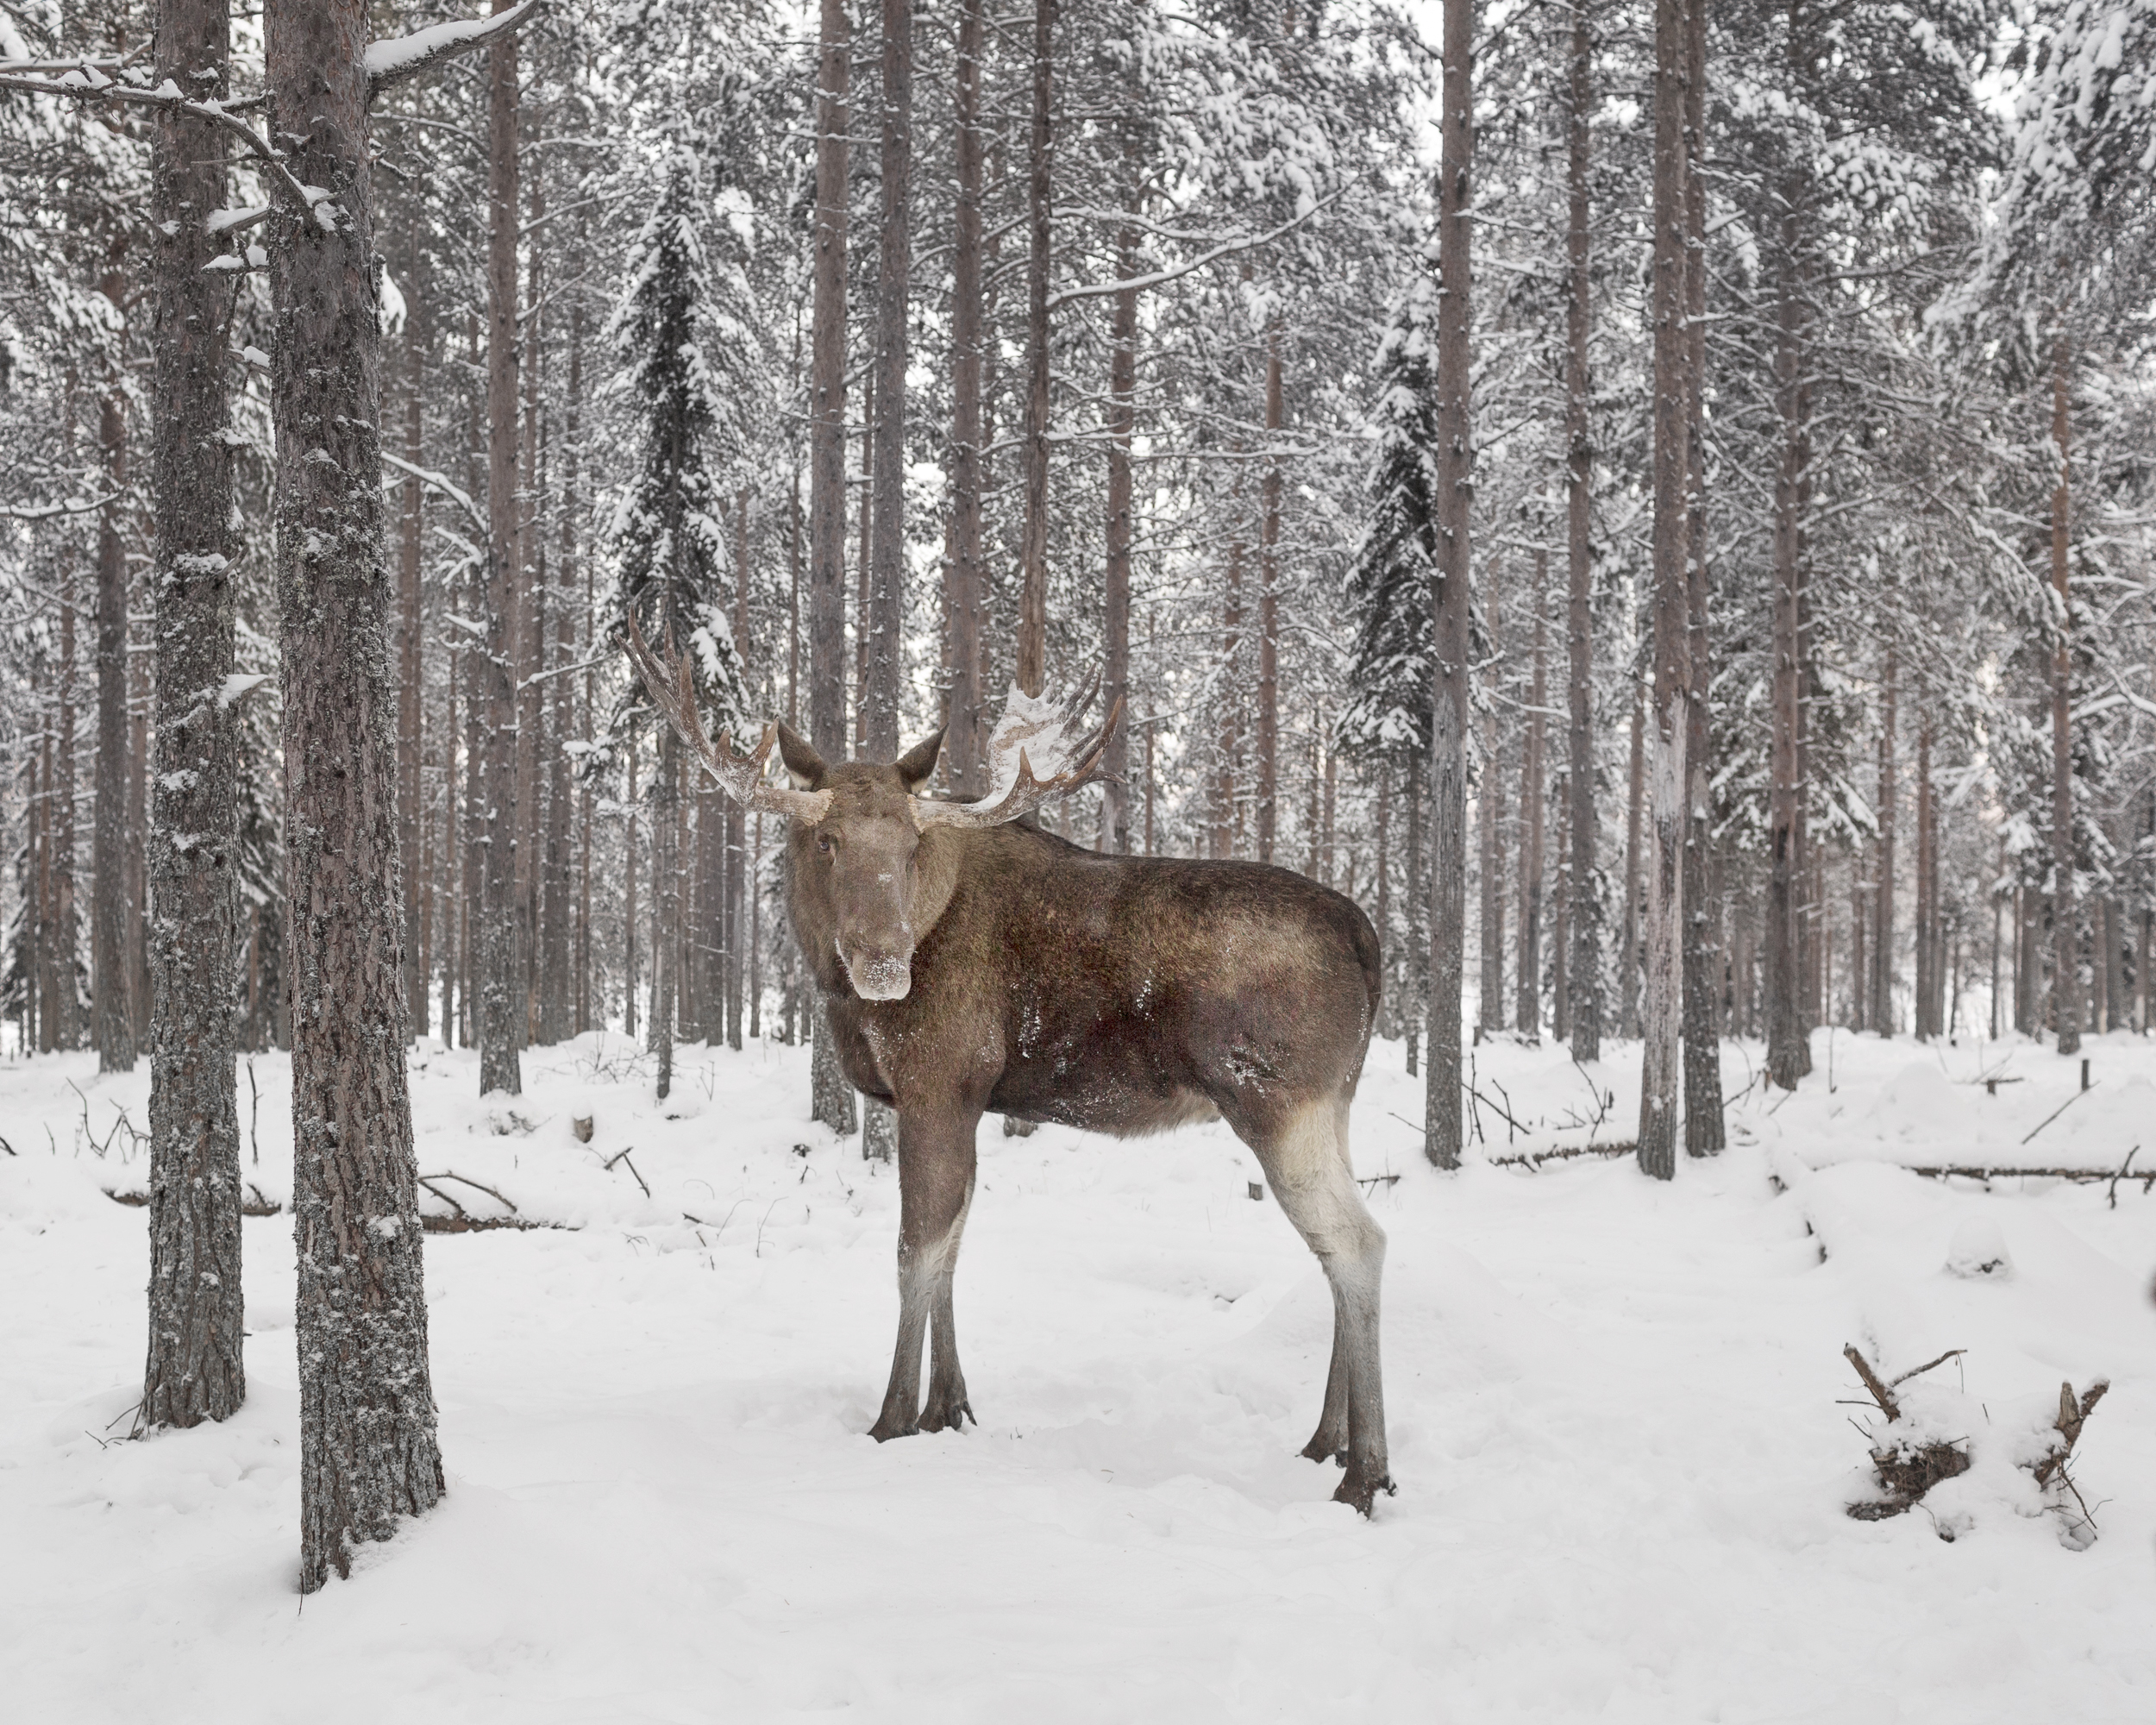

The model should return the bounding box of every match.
[470,0,524,1095]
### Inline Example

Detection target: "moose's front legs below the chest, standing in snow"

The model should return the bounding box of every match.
[869,1107,981,1443]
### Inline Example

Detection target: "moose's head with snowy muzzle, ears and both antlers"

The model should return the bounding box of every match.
[628,617,1124,1000]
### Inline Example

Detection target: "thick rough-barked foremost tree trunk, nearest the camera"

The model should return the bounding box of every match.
[263,0,442,1594]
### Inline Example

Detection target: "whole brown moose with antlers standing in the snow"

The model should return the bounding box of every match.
[628,619,1393,1516]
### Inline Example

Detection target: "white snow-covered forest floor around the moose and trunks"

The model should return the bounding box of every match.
[0,1033,2156,1725]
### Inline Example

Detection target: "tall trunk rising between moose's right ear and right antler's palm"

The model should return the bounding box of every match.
[944,0,987,798]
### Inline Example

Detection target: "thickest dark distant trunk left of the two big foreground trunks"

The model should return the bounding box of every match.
[91,267,136,1072]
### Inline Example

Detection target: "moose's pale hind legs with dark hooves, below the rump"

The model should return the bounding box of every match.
[1257,1102,1393,1516]
